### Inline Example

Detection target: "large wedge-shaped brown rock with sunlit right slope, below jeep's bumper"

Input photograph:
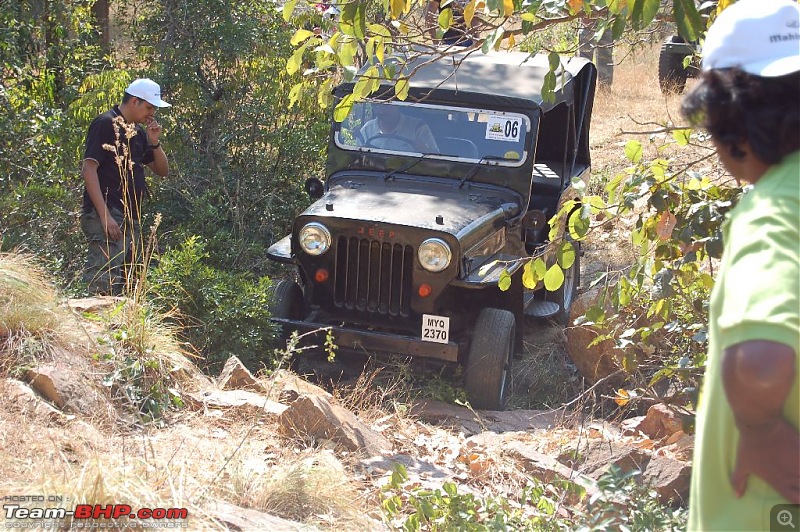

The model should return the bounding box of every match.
[278,395,392,456]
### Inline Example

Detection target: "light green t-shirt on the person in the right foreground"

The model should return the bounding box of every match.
[689,152,800,531]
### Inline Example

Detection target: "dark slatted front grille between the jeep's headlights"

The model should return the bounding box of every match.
[334,237,414,316]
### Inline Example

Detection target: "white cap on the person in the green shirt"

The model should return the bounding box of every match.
[702,0,800,77]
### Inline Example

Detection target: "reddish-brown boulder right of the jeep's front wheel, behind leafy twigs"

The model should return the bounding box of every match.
[564,286,622,386]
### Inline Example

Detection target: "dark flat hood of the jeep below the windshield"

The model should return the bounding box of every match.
[302,175,520,236]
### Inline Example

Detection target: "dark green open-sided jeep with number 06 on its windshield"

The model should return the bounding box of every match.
[269,53,597,409]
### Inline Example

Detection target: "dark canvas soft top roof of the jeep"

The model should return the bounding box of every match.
[335,50,591,112]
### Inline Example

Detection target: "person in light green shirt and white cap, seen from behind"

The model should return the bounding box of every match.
[682,0,800,530]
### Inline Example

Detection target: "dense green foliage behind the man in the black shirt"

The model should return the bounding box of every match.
[0,0,328,365]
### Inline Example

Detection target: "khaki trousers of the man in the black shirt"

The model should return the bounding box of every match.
[81,209,142,295]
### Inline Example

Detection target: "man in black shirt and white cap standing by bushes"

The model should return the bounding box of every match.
[81,79,170,294]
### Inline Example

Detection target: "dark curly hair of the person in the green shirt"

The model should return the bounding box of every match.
[681,68,800,165]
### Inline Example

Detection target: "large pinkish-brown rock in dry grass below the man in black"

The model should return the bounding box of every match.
[25,362,115,419]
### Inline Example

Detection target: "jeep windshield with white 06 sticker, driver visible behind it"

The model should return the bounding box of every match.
[335,101,531,166]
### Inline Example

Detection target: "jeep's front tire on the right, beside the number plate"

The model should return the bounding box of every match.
[464,308,516,410]
